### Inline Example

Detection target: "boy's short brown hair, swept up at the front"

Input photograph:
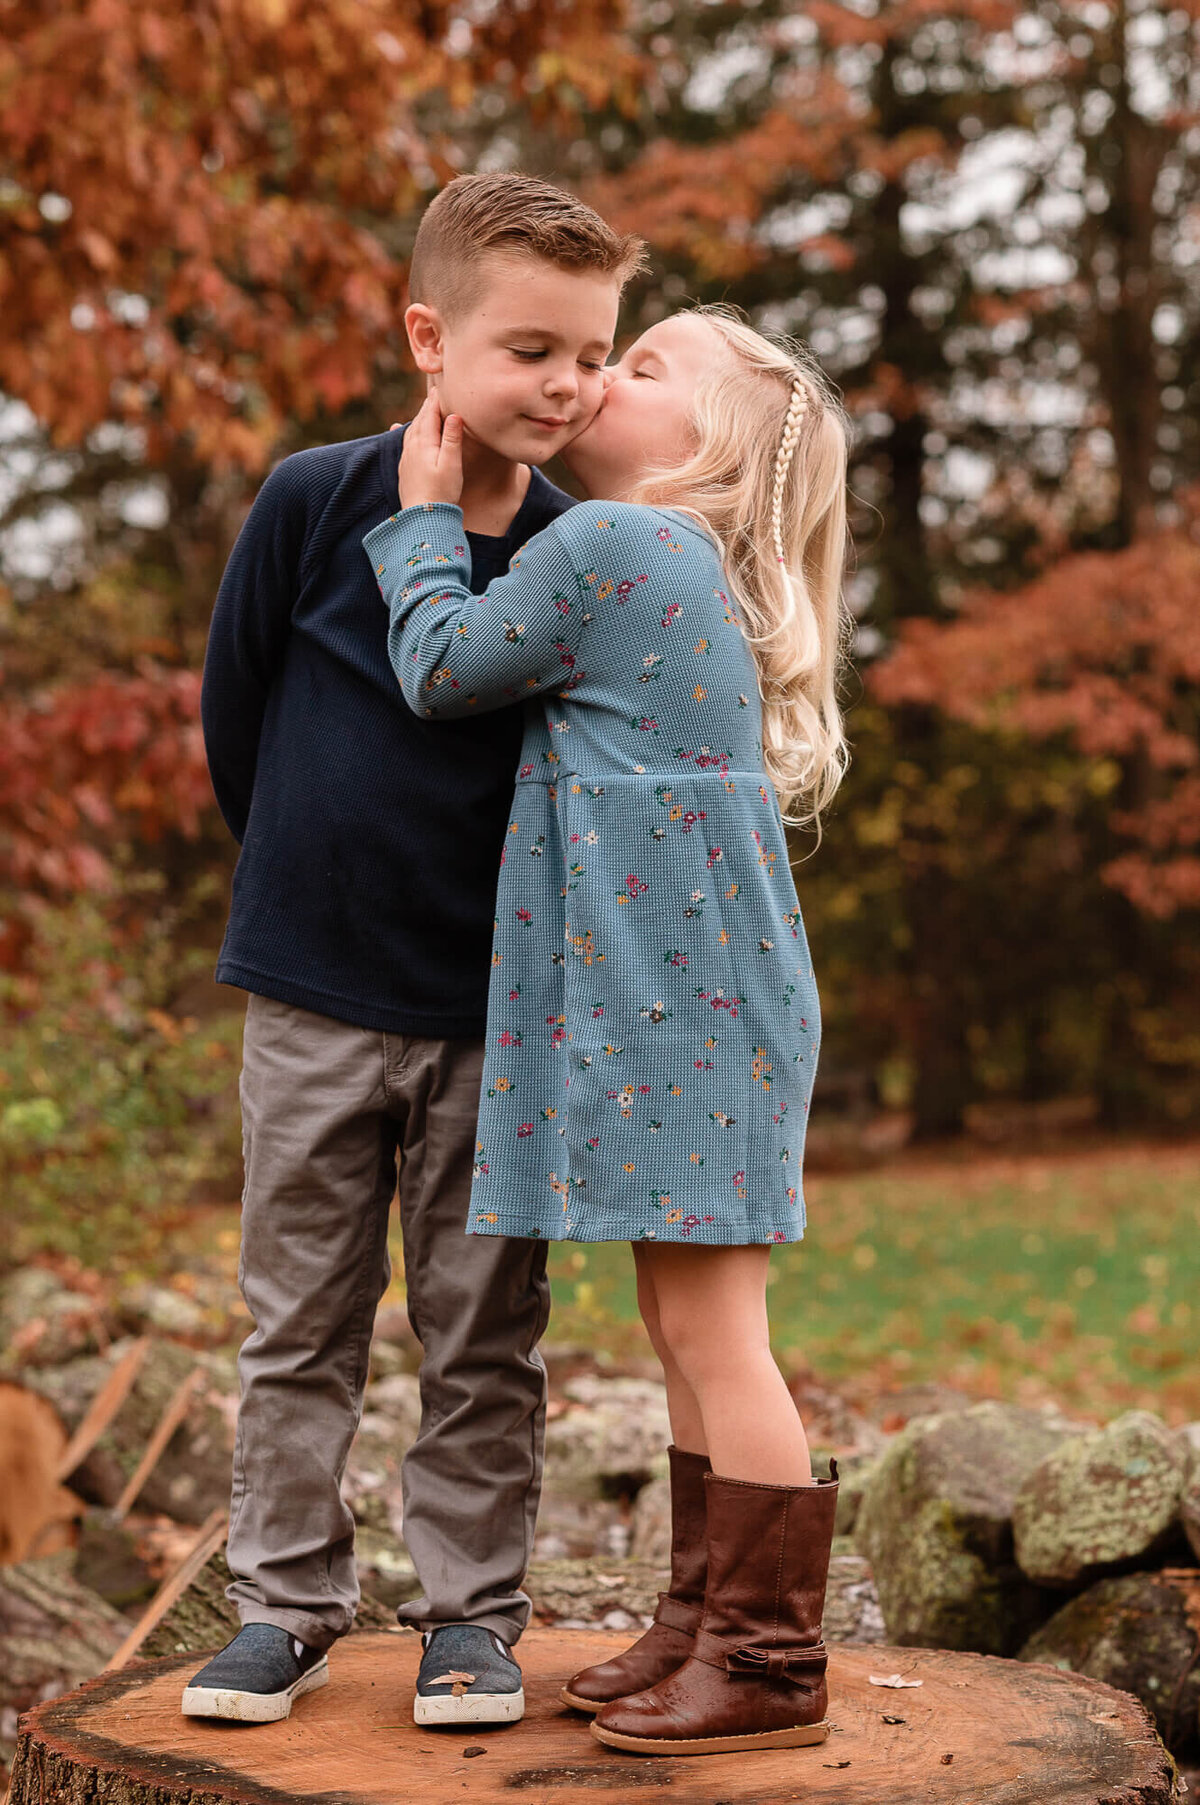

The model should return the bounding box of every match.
[408,171,646,318]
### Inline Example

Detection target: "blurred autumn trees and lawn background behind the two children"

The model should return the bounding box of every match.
[0,0,1200,1419]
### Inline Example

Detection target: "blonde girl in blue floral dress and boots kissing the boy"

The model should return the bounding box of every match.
[363,307,848,1754]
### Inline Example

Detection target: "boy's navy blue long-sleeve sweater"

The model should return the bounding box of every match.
[200,431,572,1040]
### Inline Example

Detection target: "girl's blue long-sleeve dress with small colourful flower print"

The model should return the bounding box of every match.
[363,502,819,1245]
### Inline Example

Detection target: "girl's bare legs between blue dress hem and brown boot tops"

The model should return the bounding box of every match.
[635,1242,814,1486]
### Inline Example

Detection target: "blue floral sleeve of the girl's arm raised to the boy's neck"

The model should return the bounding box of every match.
[363,502,590,720]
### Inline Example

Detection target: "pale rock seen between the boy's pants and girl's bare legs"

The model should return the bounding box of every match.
[545,1374,671,1498]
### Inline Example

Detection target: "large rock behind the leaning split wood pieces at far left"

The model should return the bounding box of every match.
[23,1341,233,1523]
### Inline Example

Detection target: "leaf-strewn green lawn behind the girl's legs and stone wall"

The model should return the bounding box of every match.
[537,1144,1200,1421]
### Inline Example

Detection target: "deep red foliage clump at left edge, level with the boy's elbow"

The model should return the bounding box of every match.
[0,661,213,893]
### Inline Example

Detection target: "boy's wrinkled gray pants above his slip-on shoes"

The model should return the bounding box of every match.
[229,996,550,1648]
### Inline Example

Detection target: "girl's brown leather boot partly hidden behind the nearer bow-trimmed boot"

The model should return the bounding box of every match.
[559,1448,713,1711]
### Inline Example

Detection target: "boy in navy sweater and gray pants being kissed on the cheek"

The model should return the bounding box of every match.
[182,175,642,1724]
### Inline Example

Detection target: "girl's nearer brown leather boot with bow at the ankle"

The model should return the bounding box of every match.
[592,1460,837,1754]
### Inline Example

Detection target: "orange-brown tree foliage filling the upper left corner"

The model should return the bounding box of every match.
[0,0,635,471]
